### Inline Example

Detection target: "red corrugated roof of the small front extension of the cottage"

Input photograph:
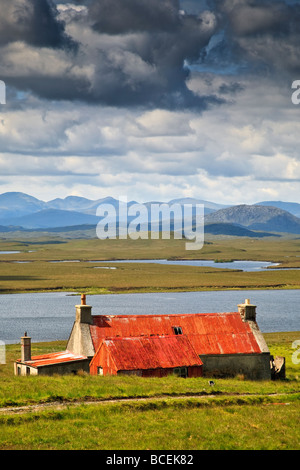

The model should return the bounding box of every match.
[95,335,202,370]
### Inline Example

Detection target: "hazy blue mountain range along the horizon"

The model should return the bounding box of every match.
[0,192,300,237]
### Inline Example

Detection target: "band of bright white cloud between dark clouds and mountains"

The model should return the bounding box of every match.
[0,72,300,203]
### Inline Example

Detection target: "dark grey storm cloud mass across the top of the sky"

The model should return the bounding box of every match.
[0,0,300,109]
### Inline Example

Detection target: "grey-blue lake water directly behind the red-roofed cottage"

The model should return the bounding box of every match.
[0,290,300,343]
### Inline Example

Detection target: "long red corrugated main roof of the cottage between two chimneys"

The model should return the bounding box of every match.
[90,312,261,355]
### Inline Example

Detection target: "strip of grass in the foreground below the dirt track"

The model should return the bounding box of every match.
[0,400,300,451]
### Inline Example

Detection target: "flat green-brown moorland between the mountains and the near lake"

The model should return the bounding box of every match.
[0,237,300,293]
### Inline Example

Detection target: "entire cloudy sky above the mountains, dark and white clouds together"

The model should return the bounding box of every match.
[0,0,300,204]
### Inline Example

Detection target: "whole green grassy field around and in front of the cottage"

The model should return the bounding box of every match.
[0,332,300,450]
